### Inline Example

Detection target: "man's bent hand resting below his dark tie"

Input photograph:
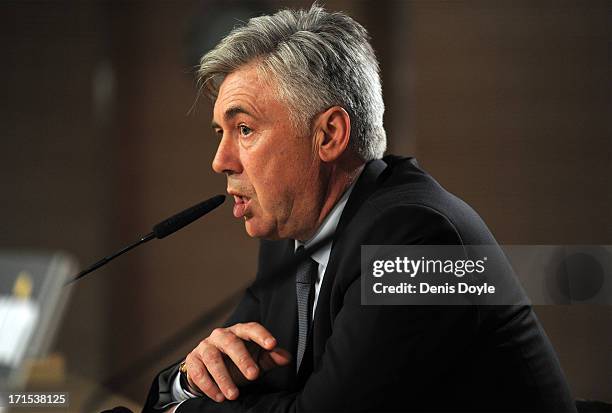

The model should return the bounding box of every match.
[185,322,291,402]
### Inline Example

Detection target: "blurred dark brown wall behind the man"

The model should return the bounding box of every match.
[0,0,612,403]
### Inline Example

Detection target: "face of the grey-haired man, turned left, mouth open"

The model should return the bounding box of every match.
[212,65,324,240]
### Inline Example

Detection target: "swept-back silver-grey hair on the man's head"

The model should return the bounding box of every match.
[197,4,387,161]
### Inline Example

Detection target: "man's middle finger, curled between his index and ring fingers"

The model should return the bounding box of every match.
[209,329,259,384]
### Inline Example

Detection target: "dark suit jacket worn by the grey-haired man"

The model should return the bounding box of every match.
[145,156,575,412]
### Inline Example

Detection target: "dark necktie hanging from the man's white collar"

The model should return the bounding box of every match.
[295,245,319,372]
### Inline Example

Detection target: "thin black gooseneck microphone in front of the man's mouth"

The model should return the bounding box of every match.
[65,195,225,285]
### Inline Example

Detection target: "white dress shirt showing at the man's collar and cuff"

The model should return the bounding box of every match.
[170,166,363,409]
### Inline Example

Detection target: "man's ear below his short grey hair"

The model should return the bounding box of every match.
[314,106,351,162]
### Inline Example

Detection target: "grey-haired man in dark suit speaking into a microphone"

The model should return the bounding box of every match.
[145,6,575,413]
